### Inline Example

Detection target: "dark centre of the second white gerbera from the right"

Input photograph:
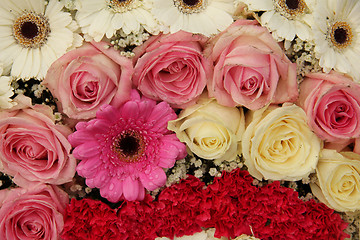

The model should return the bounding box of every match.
[274,0,307,19]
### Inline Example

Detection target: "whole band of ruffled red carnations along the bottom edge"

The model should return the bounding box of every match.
[62,169,348,240]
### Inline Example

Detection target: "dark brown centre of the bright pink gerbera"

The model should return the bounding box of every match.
[112,130,145,162]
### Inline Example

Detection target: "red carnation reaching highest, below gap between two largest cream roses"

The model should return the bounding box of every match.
[202,169,257,238]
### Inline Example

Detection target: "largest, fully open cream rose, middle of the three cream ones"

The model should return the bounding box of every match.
[242,104,322,181]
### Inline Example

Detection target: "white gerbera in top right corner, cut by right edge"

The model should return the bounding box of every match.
[313,0,360,82]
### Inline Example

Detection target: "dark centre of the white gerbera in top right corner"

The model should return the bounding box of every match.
[330,22,353,49]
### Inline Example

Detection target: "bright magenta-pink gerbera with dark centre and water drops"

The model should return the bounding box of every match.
[69,90,186,202]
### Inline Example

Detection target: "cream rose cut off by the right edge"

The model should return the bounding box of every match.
[310,149,360,212]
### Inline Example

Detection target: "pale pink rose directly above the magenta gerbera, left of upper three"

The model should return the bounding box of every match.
[44,42,133,119]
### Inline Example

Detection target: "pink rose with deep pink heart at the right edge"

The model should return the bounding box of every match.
[299,72,360,142]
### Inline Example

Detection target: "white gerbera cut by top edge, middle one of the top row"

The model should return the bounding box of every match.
[152,0,235,36]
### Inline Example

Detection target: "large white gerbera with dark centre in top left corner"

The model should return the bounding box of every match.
[0,0,82,79]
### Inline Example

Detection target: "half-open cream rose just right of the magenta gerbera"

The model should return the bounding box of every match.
[168,94,245,163]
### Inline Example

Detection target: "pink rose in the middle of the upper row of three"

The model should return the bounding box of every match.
[133,31,211,108]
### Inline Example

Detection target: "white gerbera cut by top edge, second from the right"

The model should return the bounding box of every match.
[240,0,315,41]
